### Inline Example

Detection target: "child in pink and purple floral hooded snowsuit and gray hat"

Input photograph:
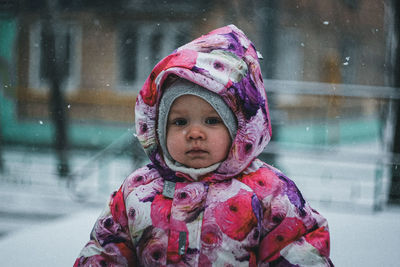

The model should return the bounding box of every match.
[75,25,333,266]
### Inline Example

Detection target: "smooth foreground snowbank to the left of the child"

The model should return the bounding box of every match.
[0,209,100,267]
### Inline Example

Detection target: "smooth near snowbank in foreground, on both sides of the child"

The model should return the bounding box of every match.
[0,208,400,267]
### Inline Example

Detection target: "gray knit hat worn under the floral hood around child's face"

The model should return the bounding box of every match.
[157,78,237,168]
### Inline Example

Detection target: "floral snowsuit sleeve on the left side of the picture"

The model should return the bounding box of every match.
[74,187,136,267]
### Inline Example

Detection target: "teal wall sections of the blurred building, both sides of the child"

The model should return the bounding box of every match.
[0,17,381,151]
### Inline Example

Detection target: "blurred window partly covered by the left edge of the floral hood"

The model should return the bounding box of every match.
[118,22,189,92]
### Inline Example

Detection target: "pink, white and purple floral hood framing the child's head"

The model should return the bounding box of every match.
[135,25,271,181]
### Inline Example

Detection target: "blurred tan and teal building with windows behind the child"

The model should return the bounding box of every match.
[0,0,392,209]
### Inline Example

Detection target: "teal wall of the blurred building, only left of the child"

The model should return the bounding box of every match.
[0,17,132,148]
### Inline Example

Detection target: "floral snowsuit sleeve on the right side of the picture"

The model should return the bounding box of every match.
[239,166,333,266]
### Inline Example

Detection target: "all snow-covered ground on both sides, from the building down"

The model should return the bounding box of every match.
[0,142,400,267]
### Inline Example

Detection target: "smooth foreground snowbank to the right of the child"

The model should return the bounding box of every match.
[321,209,400,267]
